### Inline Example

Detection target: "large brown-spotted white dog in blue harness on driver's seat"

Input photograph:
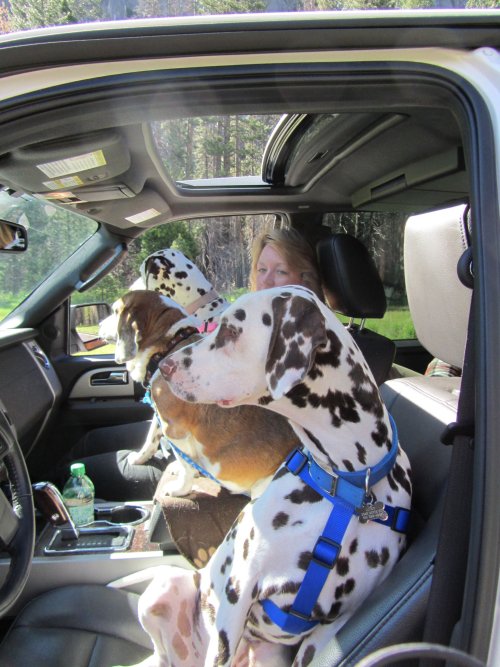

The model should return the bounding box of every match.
[133,286,411,667]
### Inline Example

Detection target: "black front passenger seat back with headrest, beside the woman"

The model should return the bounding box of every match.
[317,234,396,385]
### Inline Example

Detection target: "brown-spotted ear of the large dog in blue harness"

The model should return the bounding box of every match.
[266,294,327,399]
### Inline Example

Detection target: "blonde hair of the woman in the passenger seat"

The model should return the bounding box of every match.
[250,228,325,301]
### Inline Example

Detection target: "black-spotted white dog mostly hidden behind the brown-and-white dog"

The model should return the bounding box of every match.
[99,248,229,470]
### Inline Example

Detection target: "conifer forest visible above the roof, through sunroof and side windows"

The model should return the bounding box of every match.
[0,0,492,328]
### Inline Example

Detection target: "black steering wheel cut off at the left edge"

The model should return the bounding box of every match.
[0,403,35,618]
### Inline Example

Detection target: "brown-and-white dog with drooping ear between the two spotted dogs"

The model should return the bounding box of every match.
[107,290,298,497]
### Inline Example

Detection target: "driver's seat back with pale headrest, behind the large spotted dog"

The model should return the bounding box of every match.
[311,206,470,667]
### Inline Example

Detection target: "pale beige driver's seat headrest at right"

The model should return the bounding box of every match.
[404,206,471,368]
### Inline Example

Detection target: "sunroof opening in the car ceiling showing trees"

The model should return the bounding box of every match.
[151,114,281,187]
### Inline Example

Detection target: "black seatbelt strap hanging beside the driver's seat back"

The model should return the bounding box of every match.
[421,239,475,667]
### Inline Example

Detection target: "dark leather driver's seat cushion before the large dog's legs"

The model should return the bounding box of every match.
[0,584,153,667]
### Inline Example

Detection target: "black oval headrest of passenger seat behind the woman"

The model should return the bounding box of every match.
[317,234,387,318]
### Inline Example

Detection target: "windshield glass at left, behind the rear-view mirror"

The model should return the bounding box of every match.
[0,190,98,321]
